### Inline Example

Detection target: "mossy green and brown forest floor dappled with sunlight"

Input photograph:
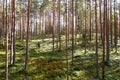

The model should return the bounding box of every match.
[0,39,120,80]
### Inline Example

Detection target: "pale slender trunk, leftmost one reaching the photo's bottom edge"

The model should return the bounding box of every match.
[5,0,8,80]
